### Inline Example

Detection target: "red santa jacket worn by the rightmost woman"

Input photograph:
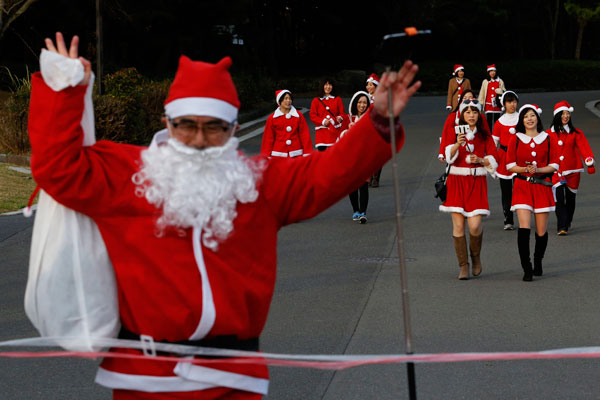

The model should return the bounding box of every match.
[546,125,596,191]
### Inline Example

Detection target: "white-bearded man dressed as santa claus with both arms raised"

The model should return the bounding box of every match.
[29,33,420,399]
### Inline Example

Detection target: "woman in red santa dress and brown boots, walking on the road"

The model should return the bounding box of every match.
[440,99,498,280]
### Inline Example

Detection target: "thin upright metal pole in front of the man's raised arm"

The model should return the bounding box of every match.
[386,66,417,400]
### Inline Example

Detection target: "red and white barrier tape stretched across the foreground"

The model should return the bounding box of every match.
[0,338,600,370]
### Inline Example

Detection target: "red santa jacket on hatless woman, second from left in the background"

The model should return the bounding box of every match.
[309,96,346,147]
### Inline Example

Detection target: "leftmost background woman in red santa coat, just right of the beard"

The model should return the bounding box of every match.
[260,89,312,157]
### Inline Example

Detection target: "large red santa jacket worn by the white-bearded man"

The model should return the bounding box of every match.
[28,73,404,398]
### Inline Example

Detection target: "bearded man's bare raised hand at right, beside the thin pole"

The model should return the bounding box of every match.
[373,60,421,117]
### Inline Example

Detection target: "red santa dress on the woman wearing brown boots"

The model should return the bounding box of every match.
[440,128,498,217]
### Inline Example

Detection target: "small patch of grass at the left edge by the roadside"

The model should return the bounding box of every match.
[0,163,35,214]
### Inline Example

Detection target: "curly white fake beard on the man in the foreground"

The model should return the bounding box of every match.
[132,137,265,251]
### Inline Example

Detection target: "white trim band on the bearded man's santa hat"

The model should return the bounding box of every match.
[165,97,238,123]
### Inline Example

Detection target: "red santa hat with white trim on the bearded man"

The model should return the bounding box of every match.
[165,56,240,123]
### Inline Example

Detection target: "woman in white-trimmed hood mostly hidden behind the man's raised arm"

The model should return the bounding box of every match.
[340,91,371,224]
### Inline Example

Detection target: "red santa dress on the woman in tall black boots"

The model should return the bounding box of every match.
[506,132,559,213]
